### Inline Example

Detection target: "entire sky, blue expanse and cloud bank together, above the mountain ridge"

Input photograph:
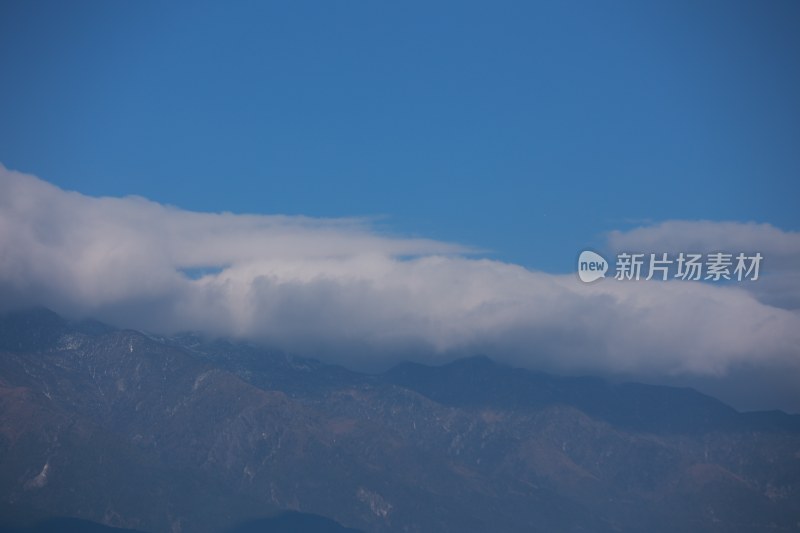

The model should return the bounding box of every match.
[0,1,800,412]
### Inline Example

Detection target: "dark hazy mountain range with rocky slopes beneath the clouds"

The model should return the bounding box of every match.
[0,309,800,533]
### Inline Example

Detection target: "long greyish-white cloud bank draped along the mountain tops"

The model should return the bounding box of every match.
[0,166,800,396]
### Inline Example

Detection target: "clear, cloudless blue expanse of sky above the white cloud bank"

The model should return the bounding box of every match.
[0,1,800,272]
